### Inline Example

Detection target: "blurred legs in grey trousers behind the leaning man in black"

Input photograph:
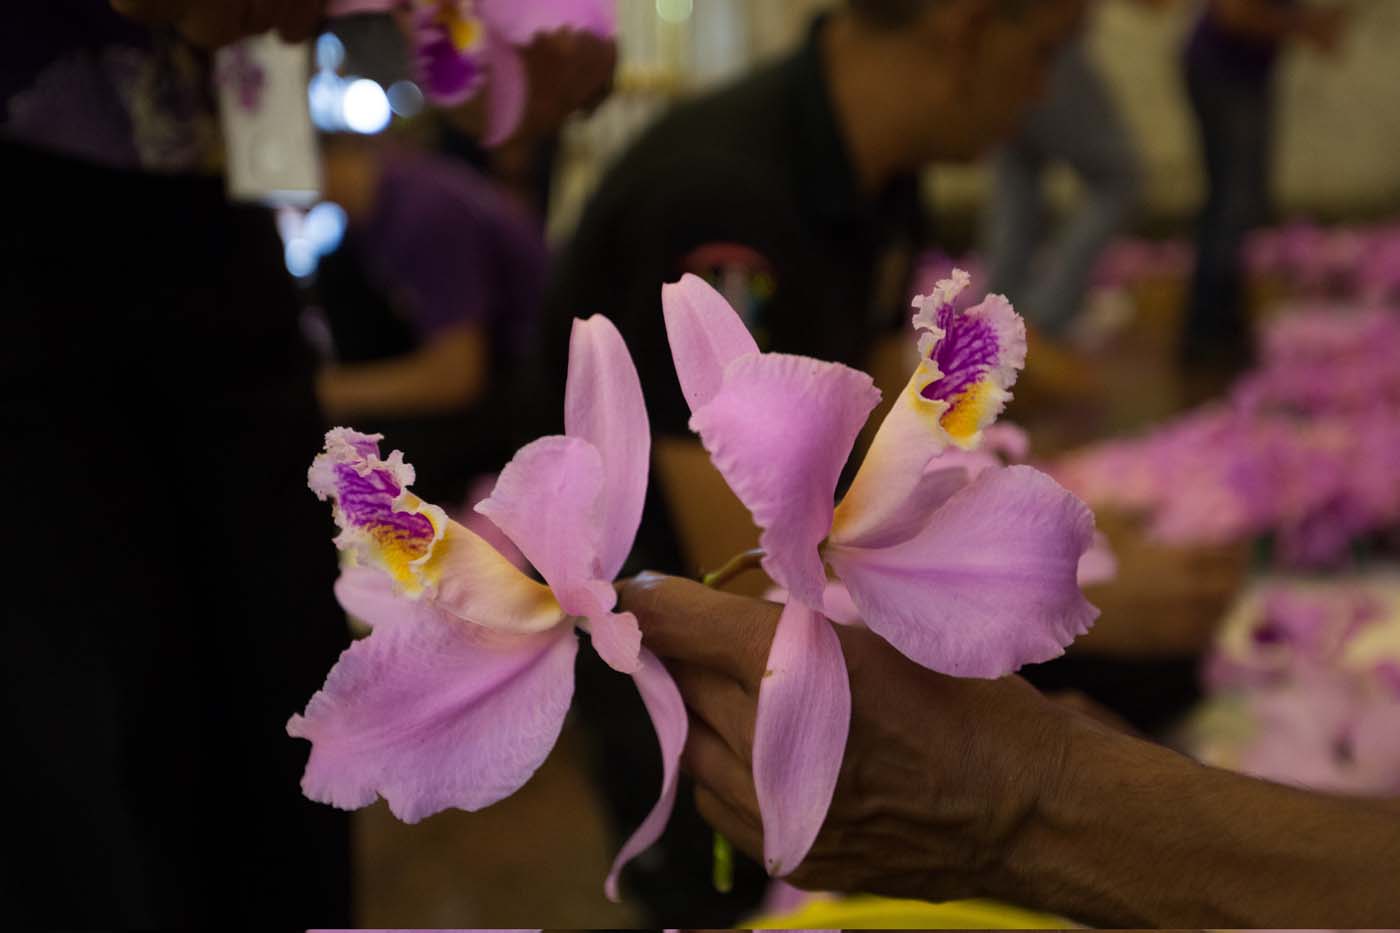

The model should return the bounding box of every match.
[983,0,1170,358]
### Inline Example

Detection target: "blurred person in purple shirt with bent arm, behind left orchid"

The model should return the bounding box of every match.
[316,137,549,503]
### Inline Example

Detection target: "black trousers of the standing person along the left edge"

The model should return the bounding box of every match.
[0,146,350,929]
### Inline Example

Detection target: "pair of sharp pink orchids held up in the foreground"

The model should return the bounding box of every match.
[287,273,1098,897]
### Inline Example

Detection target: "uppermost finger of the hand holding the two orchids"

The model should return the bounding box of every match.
[620,574,778,689]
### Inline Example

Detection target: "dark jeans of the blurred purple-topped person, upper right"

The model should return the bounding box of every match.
[1182,62,1274,367]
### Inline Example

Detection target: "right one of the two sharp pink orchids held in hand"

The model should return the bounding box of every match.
[662,267,1096,877]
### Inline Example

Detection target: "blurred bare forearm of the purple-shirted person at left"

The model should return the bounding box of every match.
[316,324,490,419]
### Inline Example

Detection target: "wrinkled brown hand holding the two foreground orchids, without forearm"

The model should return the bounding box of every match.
[622,576,1071,899]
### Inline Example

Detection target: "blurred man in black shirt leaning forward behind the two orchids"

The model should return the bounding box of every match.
[522,0,1084,927]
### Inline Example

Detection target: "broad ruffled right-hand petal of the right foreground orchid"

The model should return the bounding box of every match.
[827,467,1098,678]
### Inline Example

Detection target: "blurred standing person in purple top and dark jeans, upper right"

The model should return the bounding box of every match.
[1182,0,1345,383]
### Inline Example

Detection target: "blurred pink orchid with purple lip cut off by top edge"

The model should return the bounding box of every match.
[328,0,617,146]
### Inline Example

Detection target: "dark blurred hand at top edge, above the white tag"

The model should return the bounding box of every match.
[111,0,326,49]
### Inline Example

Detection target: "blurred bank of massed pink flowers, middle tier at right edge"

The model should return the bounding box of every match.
[1054,311,1400,567]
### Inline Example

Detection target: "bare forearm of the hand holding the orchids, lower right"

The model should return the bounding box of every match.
[995,711,1400,927]
